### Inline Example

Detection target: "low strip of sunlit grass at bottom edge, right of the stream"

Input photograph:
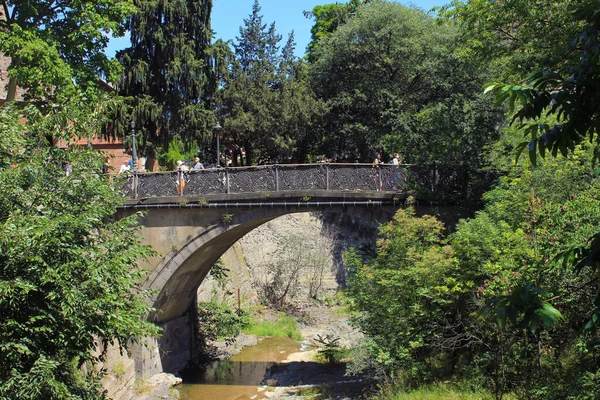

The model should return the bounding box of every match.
[377,384,500,400]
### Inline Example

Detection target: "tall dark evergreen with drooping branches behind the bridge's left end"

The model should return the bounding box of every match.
[117,0,215,153]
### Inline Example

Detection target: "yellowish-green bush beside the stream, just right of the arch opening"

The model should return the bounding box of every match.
[345,209,460,379]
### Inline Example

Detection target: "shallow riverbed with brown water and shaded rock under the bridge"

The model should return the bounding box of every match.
[178,337,367,400]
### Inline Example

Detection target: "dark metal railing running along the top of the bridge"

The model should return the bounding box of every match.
[123,163,478,199]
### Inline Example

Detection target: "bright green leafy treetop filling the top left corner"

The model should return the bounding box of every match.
[0,0,135,100]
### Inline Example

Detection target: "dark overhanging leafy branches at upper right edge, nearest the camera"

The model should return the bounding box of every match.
[478,1,600,165]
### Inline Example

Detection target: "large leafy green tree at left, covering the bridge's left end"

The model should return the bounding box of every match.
[0,97,157,399]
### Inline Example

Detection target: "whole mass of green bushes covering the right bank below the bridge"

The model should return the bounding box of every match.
[345,150,600,399]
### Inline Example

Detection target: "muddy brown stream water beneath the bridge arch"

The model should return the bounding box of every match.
[178,337,300,400]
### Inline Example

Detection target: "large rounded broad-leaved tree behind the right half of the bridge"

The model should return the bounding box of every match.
[311,1,502,167]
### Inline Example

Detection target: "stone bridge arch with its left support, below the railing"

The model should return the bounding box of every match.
[122,201,401,377]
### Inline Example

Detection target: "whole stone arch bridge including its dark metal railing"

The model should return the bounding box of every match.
[117,164,468,377]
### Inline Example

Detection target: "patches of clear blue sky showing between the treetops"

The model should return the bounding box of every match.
[106,0,450,57]
